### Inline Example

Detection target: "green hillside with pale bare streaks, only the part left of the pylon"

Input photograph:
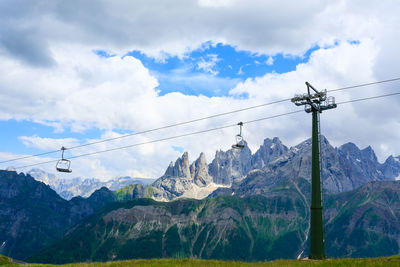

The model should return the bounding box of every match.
[27,194,307,264]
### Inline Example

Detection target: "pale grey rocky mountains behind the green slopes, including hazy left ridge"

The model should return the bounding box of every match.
[28,136,400,201]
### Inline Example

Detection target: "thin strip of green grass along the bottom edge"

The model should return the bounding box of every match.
[0,255,400,267]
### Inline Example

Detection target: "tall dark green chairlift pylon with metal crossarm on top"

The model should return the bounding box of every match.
[291,82,337,259]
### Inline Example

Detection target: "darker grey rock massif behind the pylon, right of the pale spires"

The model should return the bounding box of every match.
[212,136,400,196]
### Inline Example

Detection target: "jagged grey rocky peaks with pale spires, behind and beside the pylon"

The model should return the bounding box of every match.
[149,136,400,200]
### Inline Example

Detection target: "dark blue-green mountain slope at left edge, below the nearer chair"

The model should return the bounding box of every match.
[0,170,114,259]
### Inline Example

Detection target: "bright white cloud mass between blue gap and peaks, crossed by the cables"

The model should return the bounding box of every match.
[2,40,400,179]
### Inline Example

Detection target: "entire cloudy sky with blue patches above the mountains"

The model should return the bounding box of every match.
[0,0,400,180]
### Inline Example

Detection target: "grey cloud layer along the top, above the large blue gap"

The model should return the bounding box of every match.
[0,0,388,61]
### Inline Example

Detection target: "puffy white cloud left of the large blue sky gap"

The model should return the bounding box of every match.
[0,45,158,131]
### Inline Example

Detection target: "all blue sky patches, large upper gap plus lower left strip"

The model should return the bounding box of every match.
[0,42,318,159]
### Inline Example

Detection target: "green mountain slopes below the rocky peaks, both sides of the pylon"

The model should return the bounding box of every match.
[27,182,400,264]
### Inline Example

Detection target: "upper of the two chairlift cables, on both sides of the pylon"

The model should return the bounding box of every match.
[0,77,400,164]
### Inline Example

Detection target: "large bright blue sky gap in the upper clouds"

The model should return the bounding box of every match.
[125,42,319,97]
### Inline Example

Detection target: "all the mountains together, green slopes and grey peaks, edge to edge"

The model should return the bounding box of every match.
[0,137,400,263]
